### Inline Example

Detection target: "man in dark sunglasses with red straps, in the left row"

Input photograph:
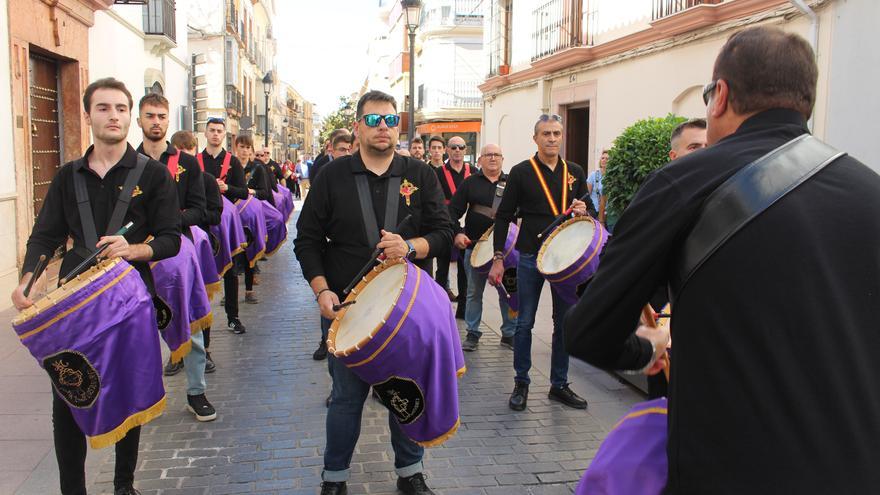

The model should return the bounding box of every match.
[196,117,248,334]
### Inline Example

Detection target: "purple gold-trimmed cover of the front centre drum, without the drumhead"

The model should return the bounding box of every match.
[328,262,466,447]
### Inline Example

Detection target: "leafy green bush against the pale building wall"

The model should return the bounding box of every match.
[602,114,687,217]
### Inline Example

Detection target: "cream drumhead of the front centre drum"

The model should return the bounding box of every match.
[333,263,407,354]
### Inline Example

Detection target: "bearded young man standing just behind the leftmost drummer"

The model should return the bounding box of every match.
[137,93,217,421]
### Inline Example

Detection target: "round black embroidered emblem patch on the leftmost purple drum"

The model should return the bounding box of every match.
[43,351,101,409]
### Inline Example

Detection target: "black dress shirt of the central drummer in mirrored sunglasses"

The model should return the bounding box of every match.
[294,153,452,295]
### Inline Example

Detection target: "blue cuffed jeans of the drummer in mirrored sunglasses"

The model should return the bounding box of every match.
[321,355,425,482]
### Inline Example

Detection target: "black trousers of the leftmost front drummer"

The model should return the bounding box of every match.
[52,391,141,495]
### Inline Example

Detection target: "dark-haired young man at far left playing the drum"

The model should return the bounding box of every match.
[12,78,180,495]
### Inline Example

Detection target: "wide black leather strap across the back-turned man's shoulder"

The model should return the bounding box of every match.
[669,134,845,298]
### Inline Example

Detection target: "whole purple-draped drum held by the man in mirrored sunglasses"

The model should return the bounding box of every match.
[327,260,466,447]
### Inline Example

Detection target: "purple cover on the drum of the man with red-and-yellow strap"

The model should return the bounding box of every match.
[537,216,608,304]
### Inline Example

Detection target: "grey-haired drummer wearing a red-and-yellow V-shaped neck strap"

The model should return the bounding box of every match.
[489,114,587,411]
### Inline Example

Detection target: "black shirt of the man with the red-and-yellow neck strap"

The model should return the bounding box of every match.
[495,154,595,254]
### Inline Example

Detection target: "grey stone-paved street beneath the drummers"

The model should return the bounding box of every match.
[0,205,642,495]
